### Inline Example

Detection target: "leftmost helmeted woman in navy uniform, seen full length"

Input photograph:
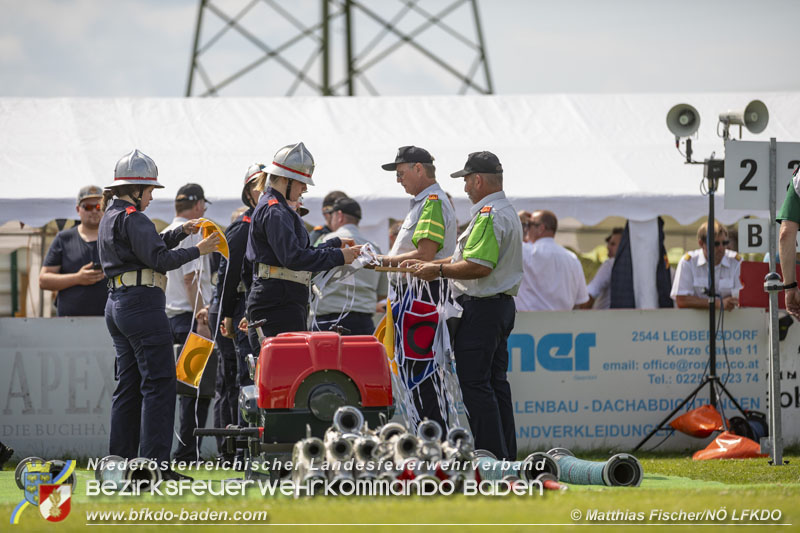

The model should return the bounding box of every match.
[97,150,220,479]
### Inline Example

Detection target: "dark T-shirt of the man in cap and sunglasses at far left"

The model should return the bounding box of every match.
[44,226,108,316]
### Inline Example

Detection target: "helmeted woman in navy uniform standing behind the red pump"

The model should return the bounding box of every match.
[245,142,361,354]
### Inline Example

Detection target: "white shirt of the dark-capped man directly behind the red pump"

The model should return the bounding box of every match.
[317,224,389,315]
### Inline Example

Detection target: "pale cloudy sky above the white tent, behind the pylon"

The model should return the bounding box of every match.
[0,0,800,97]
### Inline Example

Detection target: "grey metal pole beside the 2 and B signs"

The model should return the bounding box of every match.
[767,137,783,466]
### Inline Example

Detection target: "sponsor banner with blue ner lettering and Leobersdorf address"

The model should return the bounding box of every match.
[508,309,768,451]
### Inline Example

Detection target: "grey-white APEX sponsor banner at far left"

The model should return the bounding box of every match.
[0,317,216,458]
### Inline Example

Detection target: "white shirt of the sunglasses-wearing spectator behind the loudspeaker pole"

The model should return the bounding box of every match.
[669,249,742,300]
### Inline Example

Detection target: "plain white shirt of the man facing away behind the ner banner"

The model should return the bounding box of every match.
[516,237,589,311]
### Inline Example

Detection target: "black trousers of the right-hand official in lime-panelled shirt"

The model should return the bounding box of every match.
[454,296,517,460]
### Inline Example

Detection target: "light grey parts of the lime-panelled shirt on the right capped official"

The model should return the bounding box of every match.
[452,191,522,298]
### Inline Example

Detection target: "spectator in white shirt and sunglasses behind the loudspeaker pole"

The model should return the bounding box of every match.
[670,222,742,311]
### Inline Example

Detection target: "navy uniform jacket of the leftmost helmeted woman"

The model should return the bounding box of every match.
[97,198,200,278]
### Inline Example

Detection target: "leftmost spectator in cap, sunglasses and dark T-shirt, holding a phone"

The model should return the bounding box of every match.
[39,185,108,316]
